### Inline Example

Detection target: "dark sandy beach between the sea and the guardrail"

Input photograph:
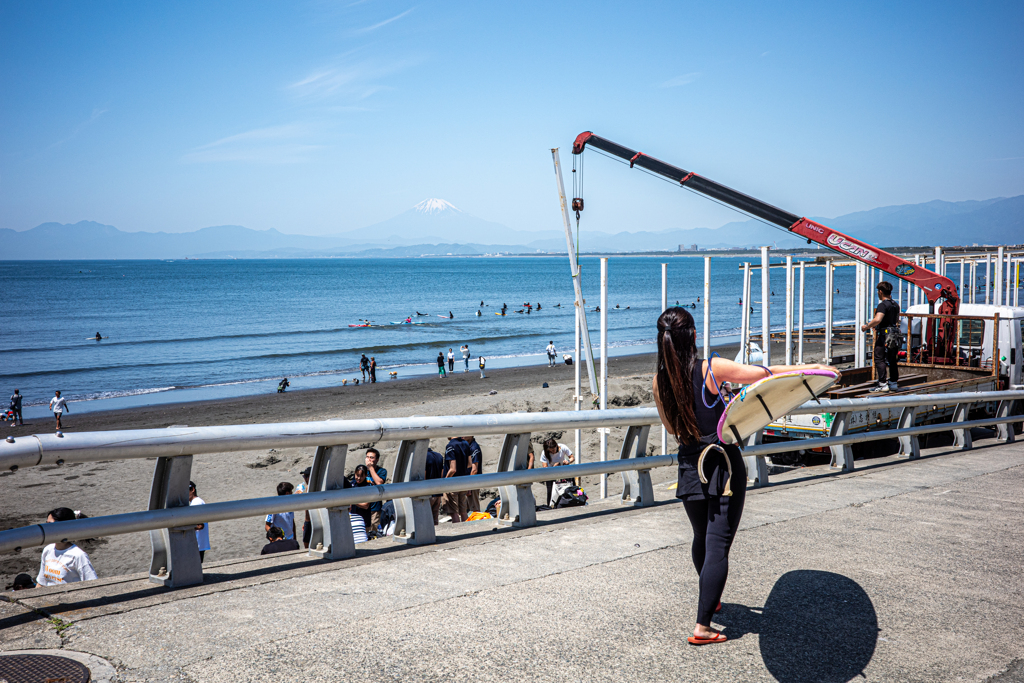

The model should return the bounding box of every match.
[0,339,820,584]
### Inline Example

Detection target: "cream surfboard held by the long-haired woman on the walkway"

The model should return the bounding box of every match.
[718,370,839,443]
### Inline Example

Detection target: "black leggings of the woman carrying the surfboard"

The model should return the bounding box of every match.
[683,485,746,627]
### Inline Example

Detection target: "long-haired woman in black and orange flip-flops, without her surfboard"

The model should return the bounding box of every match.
[654,306,838,645]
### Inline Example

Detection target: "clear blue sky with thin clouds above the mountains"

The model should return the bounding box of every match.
[0,0,1024,234]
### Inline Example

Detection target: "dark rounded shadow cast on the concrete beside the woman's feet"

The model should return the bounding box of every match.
[715,569,879,683]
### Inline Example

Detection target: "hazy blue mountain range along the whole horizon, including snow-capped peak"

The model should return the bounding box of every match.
[0,195,1024,260]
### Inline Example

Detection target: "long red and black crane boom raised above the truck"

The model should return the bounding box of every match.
[572,131,959,315]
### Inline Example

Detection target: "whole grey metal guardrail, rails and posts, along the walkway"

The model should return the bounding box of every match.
[0,390,1024,586]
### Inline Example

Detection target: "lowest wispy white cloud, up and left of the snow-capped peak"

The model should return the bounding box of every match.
[181,123,325,164]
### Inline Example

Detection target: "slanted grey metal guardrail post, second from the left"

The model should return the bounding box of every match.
[309,443,354,560]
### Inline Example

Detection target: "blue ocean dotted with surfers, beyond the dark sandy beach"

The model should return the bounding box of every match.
[0,256,854,416]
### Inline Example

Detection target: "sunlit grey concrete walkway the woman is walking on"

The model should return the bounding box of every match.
[0,440,1024,683]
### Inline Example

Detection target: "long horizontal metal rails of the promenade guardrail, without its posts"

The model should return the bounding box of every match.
[0,390,1024,552]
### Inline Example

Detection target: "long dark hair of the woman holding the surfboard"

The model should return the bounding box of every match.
[656,306,701,443]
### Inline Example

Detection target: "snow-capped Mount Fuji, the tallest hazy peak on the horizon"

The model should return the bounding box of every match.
[338,199,560,246]
